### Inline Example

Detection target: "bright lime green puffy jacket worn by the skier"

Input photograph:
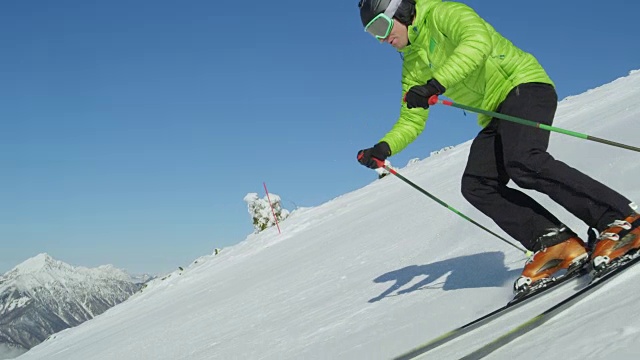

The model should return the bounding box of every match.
[380,0,553,154]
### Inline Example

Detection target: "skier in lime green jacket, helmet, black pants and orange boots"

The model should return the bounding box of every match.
[358,0,640,291]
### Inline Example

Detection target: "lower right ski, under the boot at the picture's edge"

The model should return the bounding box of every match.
[461,253,640,360]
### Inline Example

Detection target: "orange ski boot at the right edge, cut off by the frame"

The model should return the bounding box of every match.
[591,213,640,273]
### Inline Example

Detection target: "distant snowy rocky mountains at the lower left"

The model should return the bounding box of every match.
[0,254,141,358]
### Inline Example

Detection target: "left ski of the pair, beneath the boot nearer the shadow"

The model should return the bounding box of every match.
[394,266,588,360]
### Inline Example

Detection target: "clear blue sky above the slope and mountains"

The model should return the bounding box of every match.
[0,0,640,273]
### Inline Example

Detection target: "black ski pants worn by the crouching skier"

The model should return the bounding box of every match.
[462,83,632,250]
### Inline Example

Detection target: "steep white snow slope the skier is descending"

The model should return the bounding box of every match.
[20,71,640,360]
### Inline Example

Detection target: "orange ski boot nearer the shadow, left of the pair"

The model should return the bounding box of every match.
[513,227,589,295]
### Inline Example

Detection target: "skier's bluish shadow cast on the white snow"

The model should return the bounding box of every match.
[369,251,524,303]
